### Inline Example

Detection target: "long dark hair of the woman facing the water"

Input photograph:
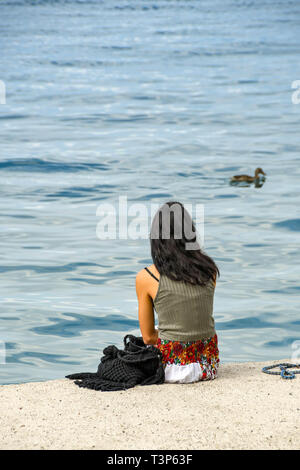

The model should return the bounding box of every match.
[150,201,220,286]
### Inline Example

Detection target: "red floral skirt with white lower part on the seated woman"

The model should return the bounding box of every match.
[155,335,220,383]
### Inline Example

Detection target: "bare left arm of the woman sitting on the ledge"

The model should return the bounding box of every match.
[136,269,158,344]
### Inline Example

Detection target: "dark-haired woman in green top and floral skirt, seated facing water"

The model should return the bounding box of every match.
[136,202,219,383]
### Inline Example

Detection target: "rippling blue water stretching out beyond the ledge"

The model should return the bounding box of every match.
[0,0,300,383]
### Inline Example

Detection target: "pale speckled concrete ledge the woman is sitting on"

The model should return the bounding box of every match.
[0,359,300,450]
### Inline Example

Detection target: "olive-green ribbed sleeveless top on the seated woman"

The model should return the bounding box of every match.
[153,275,216,342]
